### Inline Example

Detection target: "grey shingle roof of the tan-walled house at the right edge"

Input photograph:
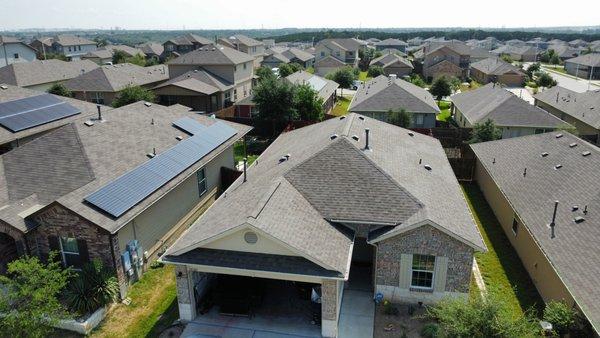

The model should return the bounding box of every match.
[471,132,600,332]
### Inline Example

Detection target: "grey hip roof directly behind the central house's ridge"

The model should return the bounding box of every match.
[348,75,440,114]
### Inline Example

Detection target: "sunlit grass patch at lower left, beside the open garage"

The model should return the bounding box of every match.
[90,265,179,337]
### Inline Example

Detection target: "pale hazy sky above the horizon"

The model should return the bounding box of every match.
[0,0,600,30]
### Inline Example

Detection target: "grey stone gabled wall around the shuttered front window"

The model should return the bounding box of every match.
[375,225,473,293]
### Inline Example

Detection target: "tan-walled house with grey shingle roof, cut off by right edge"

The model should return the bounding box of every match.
[471,132,600,337]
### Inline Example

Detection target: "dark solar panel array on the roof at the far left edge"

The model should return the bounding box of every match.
[0,94,81,133]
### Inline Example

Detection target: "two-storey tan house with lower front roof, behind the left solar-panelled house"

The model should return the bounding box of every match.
[153,45,254,112]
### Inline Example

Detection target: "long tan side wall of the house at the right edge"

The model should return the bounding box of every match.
[475,161,574,305]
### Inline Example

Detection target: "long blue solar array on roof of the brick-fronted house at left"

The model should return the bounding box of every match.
[85,119,237,217]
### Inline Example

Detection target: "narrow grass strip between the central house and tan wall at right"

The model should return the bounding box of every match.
[462,184,544,314]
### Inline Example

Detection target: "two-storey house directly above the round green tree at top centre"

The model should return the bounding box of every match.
[315,38,367,76]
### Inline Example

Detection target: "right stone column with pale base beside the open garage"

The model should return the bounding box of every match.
[321,279,344,337]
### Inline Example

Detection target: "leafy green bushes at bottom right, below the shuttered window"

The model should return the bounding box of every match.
[427,293,539,338]
